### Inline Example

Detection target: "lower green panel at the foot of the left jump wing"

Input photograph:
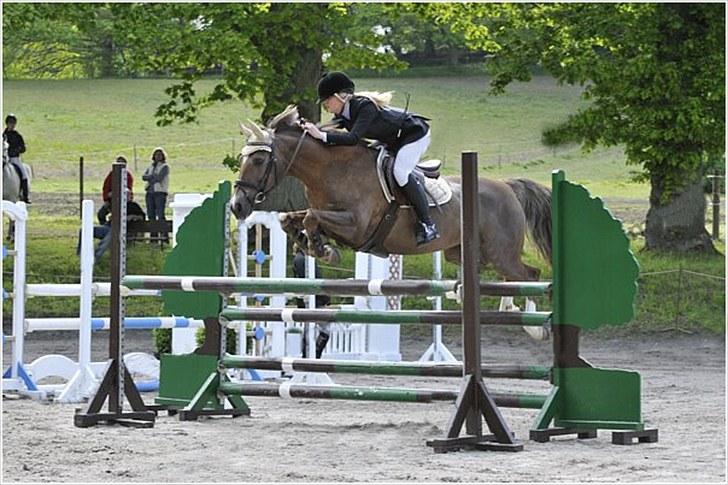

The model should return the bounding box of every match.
[155,354,217,407]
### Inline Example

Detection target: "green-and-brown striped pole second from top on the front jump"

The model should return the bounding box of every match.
[220,307,551,326]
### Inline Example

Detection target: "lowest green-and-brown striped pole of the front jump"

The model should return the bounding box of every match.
[219,382,546,409]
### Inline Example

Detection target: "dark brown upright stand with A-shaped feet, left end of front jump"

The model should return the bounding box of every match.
[73,163,156,428]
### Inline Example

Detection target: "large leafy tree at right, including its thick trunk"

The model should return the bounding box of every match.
[421,3,725,251]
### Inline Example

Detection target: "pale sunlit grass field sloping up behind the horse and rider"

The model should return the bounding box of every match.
[3,75,649,198]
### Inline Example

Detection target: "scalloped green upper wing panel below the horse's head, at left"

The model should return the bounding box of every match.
[162,181,230,319]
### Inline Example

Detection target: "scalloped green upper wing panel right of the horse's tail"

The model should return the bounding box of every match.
[552,171,639,328]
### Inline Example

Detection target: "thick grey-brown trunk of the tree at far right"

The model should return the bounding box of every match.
[645,174,716,253]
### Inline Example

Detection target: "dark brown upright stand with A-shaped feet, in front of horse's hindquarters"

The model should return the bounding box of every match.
[427,152,523,453]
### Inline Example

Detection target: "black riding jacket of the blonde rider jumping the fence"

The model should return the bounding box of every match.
[326,96,430,151]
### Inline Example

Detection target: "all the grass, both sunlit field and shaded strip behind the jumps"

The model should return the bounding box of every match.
[3,72,725,334]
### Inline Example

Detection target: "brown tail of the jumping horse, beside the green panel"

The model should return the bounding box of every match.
[505,178,551,264]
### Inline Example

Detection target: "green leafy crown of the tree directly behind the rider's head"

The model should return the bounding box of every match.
[111,3,399,124]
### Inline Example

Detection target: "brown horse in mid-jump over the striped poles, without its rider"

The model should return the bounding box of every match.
[231,106,551,281]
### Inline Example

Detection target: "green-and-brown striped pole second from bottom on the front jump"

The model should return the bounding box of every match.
[220,355,551,380]
